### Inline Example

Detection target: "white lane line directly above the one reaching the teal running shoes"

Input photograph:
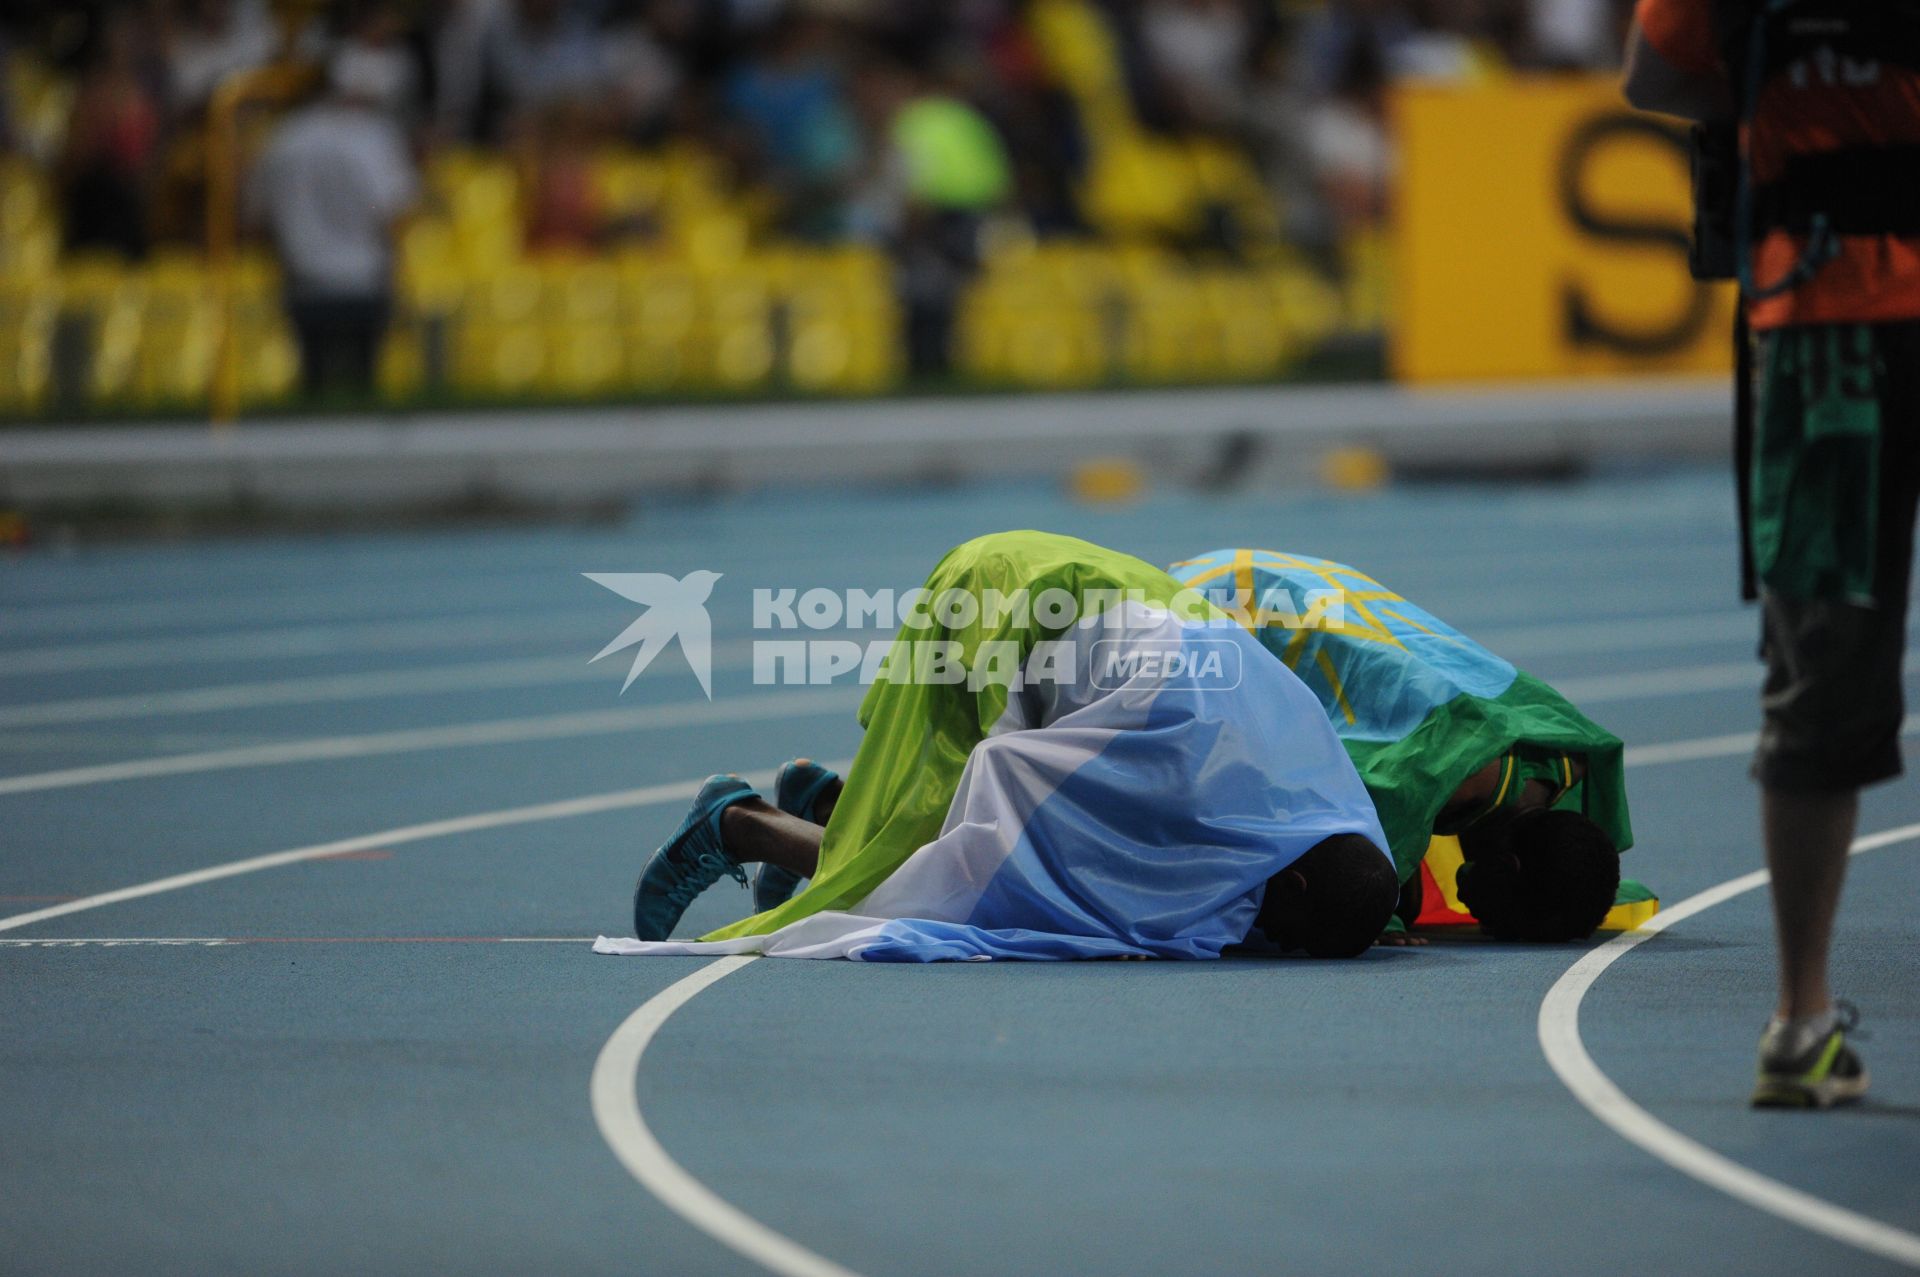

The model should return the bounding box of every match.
[0,687,860,795]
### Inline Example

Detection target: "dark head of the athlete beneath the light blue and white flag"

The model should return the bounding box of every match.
[1258,833,1400,958]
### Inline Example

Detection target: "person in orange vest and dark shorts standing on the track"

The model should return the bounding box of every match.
[1626,0,1920,1108]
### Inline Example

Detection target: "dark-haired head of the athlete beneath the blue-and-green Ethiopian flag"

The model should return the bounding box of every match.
[1459,808,1620,941]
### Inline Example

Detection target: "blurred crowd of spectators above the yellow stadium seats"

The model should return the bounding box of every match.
[0,0,1628,393]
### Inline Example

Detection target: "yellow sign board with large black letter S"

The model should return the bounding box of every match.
[1392,77,1734,382]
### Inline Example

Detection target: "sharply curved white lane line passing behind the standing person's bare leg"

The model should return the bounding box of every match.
[1540,824,1920,1267]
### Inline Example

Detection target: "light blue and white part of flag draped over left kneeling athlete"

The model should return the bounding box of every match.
[595,601,1386,962]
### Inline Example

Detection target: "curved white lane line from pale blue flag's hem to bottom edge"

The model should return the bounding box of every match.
[588,954,858,1277]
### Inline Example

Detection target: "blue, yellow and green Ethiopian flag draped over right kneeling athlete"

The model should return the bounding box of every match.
[1171,549,1644,895]
